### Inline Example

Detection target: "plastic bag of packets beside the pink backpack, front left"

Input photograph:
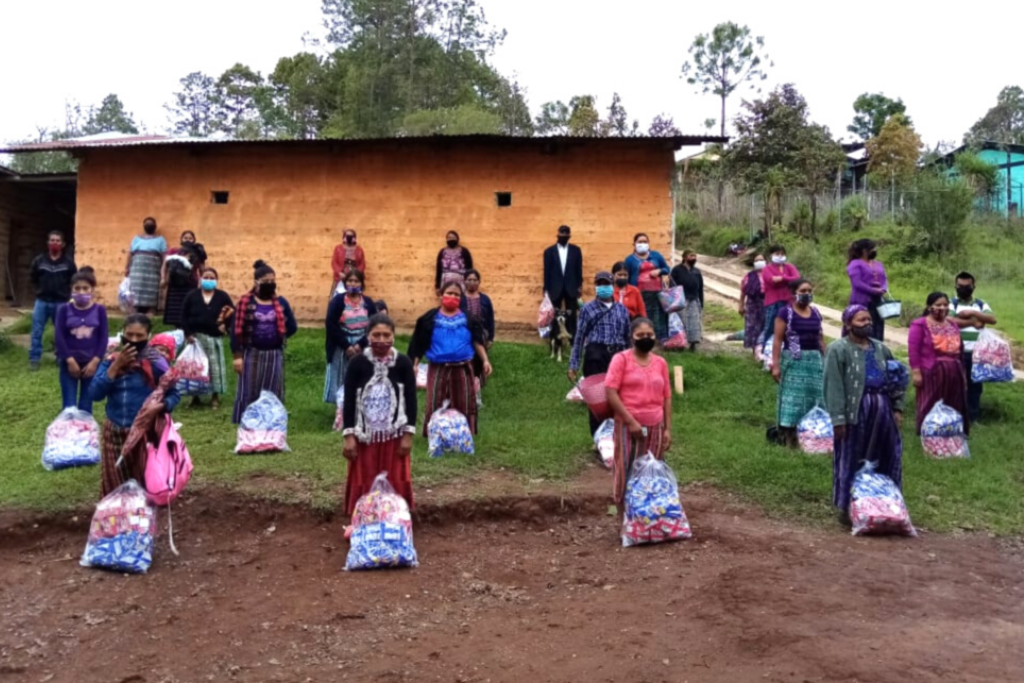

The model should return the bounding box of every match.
[80,479,157,573]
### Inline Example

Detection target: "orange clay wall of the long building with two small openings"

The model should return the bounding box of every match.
[76,140,673,328]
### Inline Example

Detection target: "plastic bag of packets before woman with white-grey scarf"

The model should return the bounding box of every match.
[345,472,420,571]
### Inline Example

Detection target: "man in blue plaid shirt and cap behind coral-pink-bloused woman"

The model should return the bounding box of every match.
[569,270,632,436]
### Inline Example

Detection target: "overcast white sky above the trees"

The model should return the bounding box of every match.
[0,0,1024,145]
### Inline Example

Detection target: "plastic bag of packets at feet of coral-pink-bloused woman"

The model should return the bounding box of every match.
[623,453,691,548]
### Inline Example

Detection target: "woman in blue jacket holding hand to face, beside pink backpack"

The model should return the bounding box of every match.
[89,313,180,496]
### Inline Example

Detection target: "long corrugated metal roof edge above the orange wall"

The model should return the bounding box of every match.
[0,133,728,154]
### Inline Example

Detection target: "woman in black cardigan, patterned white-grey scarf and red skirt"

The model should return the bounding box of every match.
[342,314,416,515]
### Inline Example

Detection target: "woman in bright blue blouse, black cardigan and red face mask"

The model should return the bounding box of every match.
[409,283,490,436]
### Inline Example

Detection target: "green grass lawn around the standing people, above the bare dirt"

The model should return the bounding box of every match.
[0,315,1024,533]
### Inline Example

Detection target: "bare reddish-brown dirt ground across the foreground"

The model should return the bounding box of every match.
[0,467,1024,683]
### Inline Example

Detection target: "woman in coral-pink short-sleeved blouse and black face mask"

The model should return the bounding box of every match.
[604,317,672,516]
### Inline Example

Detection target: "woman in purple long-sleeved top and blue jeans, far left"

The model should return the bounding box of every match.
[53,266,109,413]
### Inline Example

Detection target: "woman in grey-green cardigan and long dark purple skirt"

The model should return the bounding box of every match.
[824,304,909,524]
